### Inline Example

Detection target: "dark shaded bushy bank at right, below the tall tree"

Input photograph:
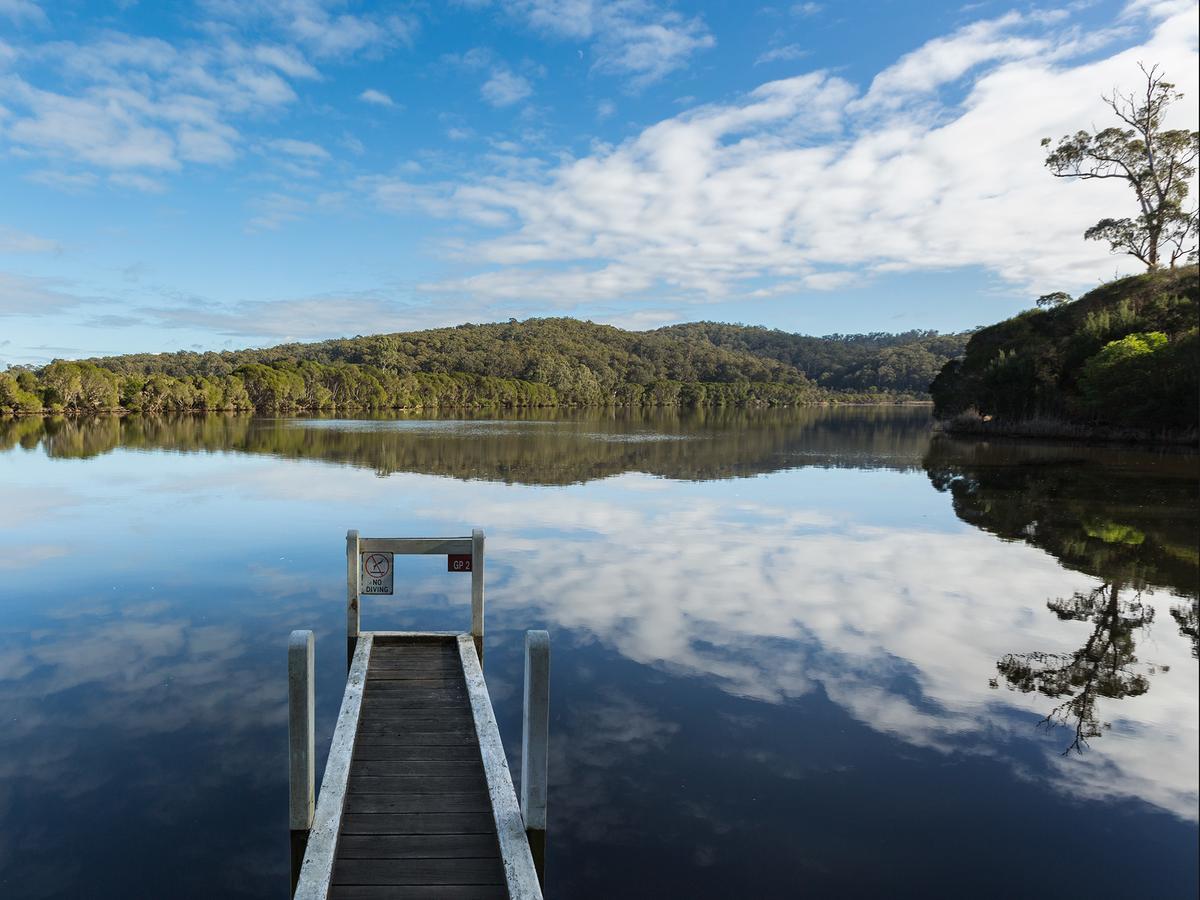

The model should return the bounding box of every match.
[930,265,1200,432]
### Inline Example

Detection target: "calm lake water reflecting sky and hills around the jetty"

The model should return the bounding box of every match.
[0,409,1200,898]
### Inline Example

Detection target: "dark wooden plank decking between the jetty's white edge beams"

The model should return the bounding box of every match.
[331,637,508,898]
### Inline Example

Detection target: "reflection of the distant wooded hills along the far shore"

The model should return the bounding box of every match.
[0,406,929,485]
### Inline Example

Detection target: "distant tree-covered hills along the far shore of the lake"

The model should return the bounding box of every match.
[0,318,966,414]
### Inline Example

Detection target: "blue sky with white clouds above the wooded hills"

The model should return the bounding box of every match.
[0,0,1198,365]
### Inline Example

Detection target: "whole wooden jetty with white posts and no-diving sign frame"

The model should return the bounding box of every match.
[288,529,550,900]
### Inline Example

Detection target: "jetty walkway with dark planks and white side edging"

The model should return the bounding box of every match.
[295,631,541,900]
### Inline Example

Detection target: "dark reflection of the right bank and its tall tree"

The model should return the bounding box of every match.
[925,438,1200,755]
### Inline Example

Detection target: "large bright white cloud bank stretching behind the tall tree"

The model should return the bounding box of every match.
[391,2,1198,306]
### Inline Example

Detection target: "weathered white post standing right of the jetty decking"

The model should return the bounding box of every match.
[521,631,550,889]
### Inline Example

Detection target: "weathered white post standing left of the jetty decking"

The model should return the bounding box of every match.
[288,631,317,893]
